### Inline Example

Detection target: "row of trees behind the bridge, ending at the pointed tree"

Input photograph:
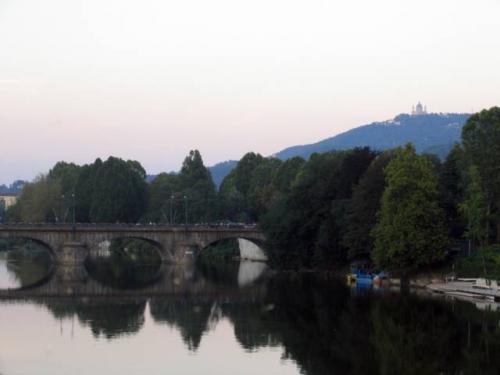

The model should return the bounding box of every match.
[7,150,216,224]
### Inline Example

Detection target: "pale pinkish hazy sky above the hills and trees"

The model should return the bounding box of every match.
[0,0,500,183]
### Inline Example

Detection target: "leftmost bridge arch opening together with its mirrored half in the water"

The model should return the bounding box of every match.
[0,239,52,289]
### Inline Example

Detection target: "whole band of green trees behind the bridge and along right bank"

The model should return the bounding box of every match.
[3,107,500,270]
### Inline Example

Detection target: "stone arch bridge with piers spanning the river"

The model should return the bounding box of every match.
[0,224,265,266]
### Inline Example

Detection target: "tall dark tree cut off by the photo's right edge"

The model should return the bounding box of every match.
[462,107,500,241]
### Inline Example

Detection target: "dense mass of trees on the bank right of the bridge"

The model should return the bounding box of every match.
[261,108,500,271]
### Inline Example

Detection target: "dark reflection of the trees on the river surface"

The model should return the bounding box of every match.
[10,267,500,375]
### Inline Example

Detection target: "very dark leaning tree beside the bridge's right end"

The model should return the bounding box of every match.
[261,148,376,268]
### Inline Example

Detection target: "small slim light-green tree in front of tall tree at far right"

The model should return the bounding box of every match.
[458,165,488,251]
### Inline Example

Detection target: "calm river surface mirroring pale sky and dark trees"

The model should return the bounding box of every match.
[0,250,500,375]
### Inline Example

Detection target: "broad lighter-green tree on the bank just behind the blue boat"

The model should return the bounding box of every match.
[372,144,448,280]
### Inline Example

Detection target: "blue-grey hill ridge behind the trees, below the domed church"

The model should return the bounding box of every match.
[209,113,470,186]
